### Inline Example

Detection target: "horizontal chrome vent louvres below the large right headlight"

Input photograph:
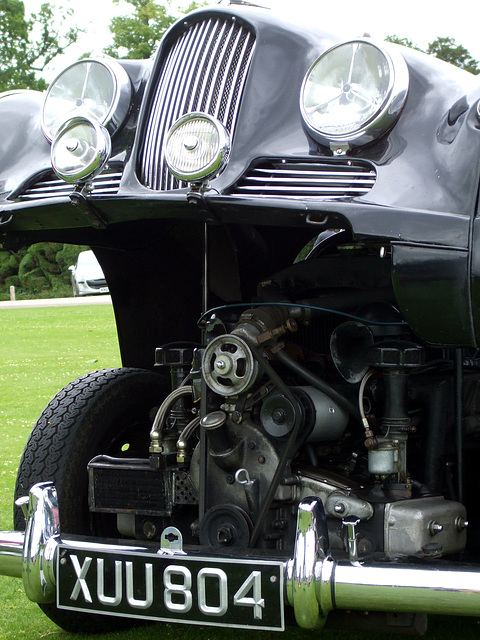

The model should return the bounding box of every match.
[231,159,377,199]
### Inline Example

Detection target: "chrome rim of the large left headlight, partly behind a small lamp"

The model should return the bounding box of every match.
[41,57,133,142]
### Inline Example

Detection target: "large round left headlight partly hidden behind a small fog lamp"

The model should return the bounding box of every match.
[42,58,132,140]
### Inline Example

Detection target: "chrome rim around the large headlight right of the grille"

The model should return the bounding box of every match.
[300,38,409,149]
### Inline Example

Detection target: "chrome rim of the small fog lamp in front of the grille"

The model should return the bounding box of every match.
[165,111,231,184]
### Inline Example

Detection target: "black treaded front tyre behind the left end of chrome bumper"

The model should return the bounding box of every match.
[14,368,170,633]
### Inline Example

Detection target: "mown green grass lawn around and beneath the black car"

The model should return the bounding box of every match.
[0,305,480,640]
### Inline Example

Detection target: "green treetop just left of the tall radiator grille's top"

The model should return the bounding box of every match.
[105,0,199,59]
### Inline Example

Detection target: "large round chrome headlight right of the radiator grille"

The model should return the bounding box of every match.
[300,40,408,146]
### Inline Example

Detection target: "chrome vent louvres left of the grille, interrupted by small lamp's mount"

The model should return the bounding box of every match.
[14,169,122,201]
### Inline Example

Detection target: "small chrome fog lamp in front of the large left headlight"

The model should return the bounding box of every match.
[51,116,112,182]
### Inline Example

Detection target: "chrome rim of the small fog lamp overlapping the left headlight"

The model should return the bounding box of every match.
[51,116,112,184]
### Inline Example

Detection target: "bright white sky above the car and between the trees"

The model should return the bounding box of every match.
[24,0,480,80]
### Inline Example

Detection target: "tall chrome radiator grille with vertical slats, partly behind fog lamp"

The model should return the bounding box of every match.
[140,18,255,191]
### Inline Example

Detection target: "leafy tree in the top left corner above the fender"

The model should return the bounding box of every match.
[0,0,79,91]
